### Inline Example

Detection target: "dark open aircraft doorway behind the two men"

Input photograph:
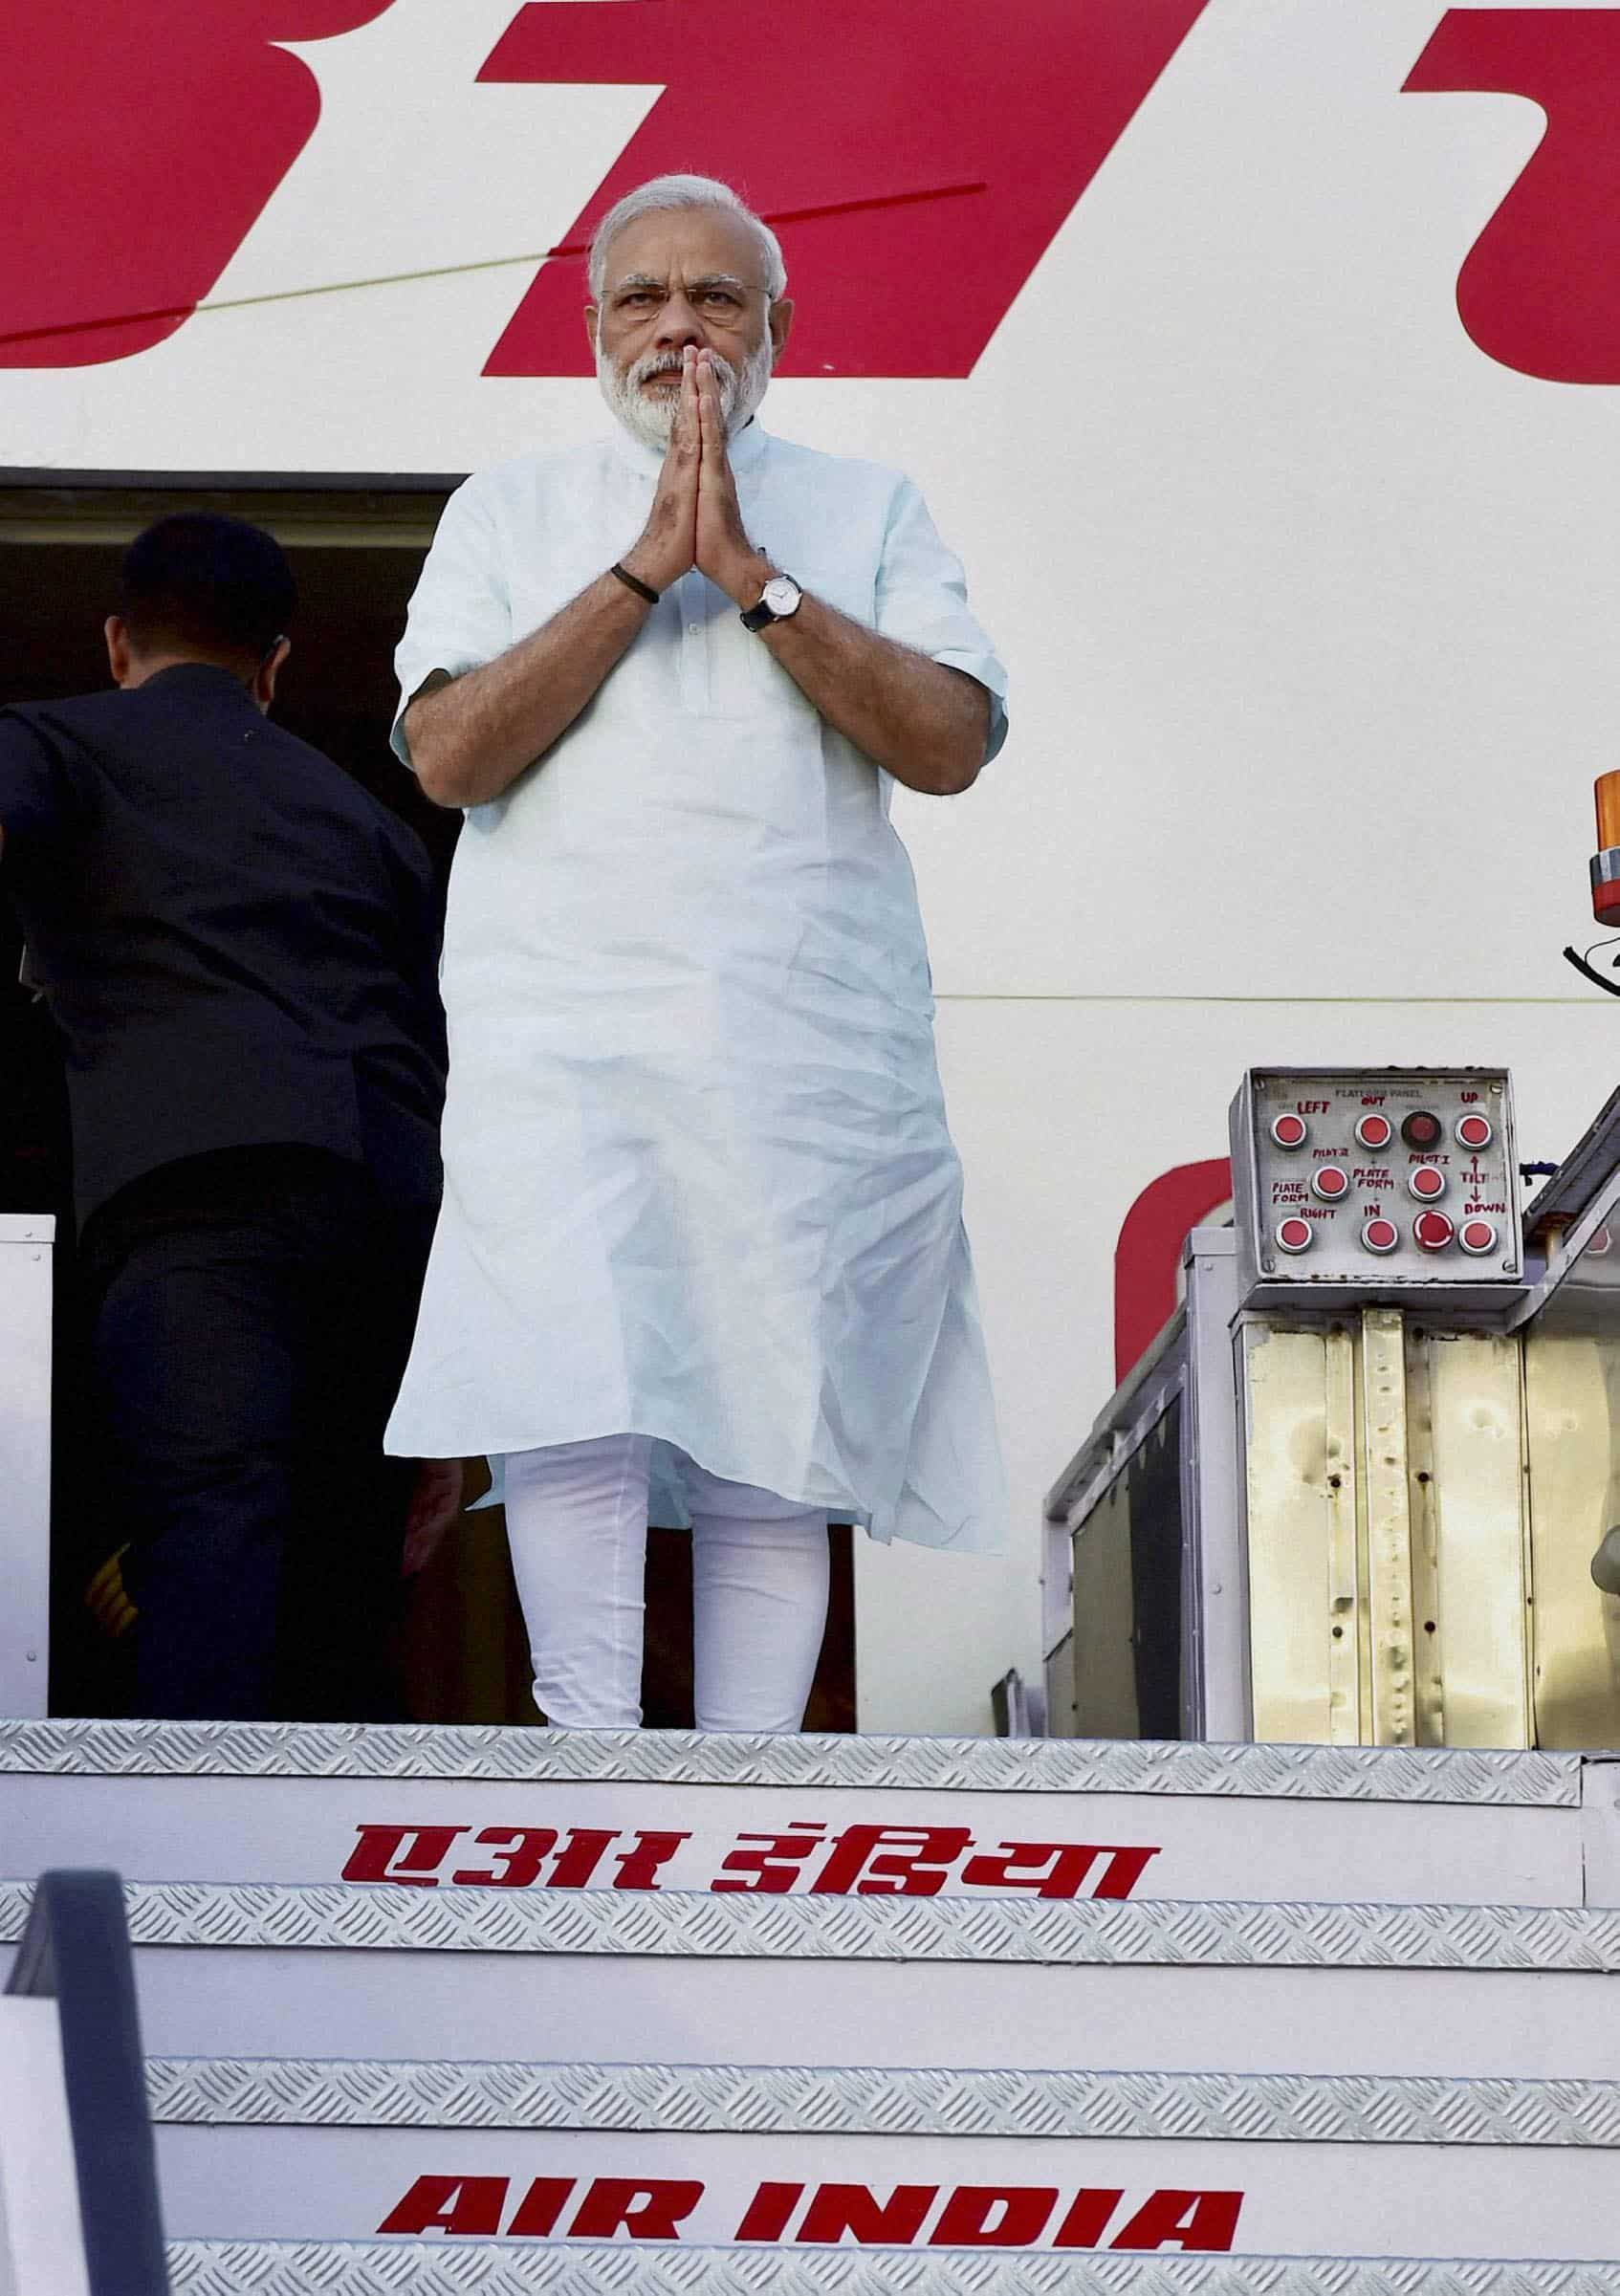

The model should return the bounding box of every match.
[0,473,856,1731]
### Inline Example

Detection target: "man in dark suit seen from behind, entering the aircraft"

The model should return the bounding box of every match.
[0,514,454,1719]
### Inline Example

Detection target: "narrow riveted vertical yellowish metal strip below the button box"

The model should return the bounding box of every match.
[1361,1306,1418,1745]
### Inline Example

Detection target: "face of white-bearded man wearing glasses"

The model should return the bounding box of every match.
[585,207,792,446]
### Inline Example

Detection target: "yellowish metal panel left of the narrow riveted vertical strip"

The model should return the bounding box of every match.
[1241,1323,1354,1745]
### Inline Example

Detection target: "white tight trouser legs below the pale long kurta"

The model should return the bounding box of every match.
[505,1435,828,1731]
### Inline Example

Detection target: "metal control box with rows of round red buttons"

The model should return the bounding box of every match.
[1232,1067,1523,1298]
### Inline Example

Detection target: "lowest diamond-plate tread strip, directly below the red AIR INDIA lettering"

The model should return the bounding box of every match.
[170,2241,1620,2296]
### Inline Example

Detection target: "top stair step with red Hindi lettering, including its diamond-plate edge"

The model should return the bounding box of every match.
[0,1722,1592,1906]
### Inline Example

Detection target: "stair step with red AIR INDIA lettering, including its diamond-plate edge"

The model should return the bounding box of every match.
[151,2060,1620,2260]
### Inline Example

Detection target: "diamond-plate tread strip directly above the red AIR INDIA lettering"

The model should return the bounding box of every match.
[147,2057,1620,2149]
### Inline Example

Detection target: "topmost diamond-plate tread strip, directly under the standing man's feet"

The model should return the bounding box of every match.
[0,1719,1584,1809]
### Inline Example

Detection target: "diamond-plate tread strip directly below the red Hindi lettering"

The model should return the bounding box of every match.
[0,1880,1620,1975]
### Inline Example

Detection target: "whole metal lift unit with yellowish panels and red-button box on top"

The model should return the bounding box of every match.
[1044,1070,1620,1747]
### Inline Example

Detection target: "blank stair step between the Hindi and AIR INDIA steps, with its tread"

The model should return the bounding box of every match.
[0,1883,1620,2080]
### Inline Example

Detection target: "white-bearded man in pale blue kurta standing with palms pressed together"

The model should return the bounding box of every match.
[390,177,1005,1731]
